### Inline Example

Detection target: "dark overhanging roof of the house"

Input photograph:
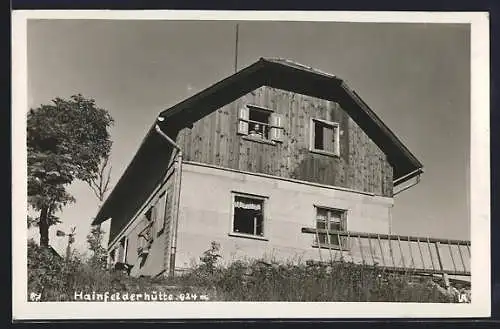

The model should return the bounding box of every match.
[93,58,423,226]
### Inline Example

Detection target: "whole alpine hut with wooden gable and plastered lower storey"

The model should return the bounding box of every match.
[93,58,422,276]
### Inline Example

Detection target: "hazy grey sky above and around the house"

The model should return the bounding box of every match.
[28,20,470,252]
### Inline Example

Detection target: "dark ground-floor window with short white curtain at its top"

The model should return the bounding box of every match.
[232,194,265,237]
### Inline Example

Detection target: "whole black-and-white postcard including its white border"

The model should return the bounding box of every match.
[12,11,490,319]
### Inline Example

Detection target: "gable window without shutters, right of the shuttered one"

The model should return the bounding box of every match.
[310,119,340,156]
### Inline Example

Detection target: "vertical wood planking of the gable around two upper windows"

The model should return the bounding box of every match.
[181,87,392,196]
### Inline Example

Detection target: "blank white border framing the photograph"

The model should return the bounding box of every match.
[11,10,491,320]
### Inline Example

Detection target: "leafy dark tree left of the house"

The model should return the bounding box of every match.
[27,94,114,247]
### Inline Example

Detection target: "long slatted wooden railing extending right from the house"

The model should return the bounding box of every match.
[302,227,471,285]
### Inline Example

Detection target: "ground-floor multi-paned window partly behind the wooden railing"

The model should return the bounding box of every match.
[316,207,347,249]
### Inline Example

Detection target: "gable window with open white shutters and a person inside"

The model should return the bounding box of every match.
[238,105,283,142]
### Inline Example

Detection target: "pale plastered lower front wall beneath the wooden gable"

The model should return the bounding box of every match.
[176,164,393,268]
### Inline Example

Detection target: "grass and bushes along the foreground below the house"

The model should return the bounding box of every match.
[28,241,466,303]
